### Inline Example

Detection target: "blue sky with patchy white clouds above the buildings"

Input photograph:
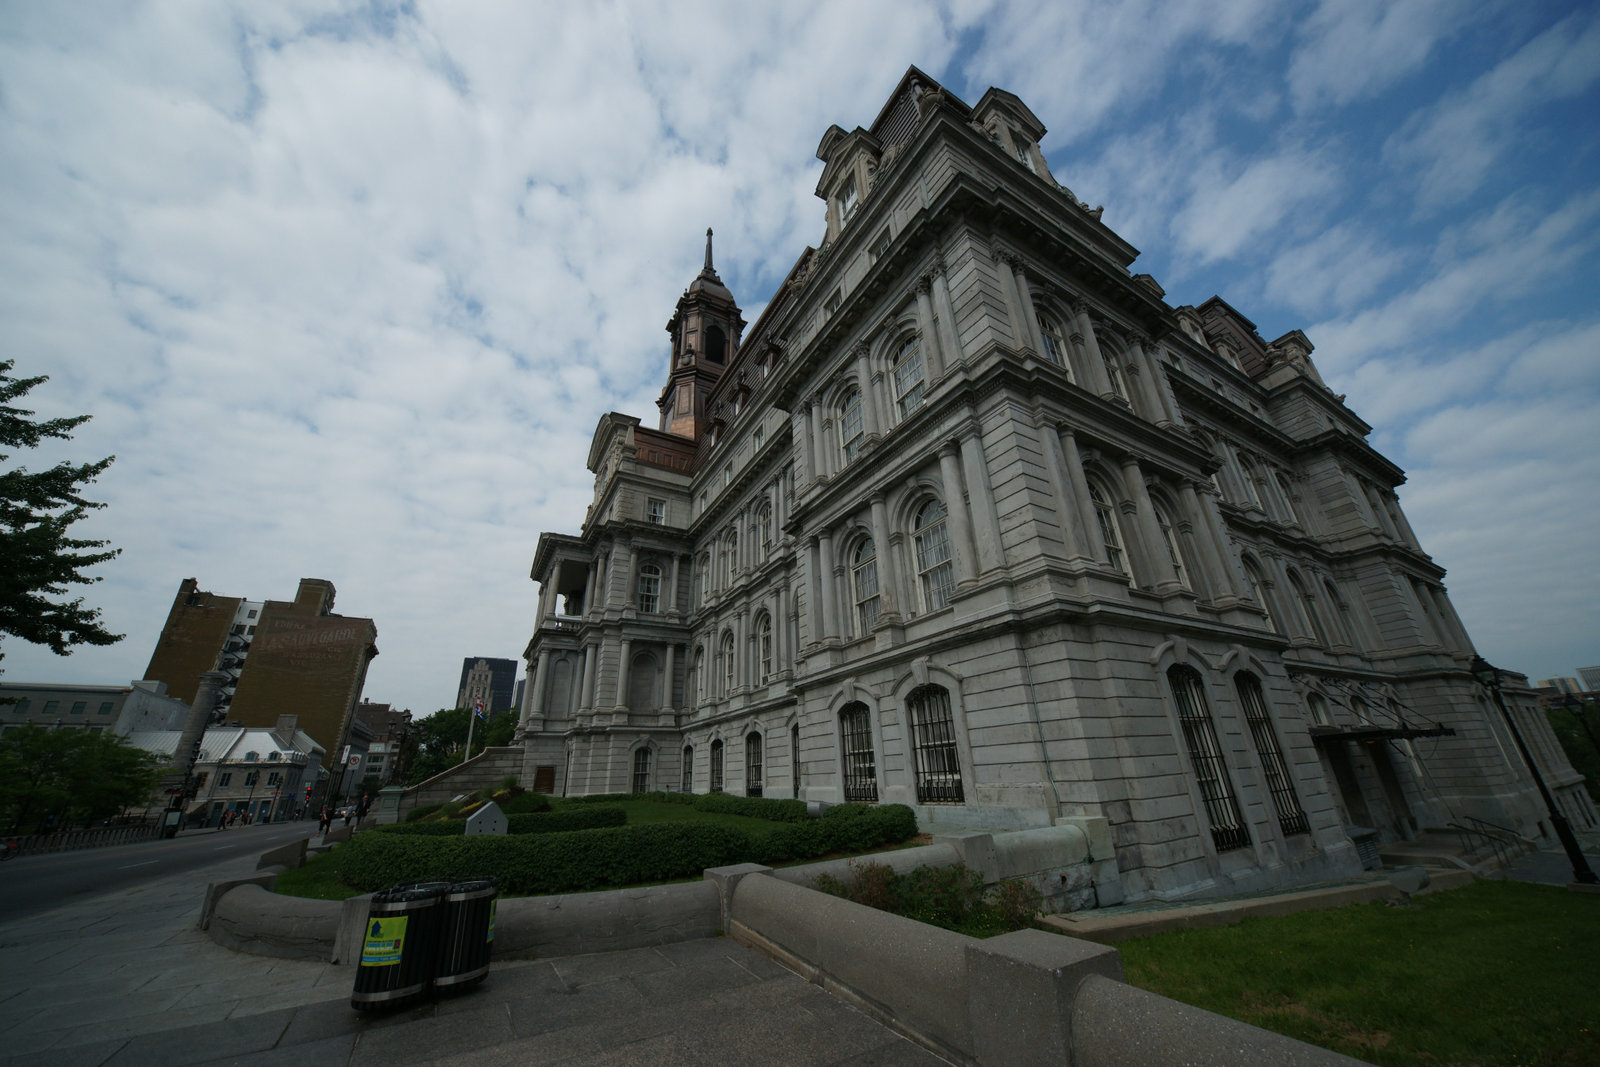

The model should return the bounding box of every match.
[0,0,1600,712]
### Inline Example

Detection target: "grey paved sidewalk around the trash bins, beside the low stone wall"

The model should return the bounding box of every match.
[0,856,944,1067]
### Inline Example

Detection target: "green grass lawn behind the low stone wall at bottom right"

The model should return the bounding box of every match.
[1117,881,1600,1067]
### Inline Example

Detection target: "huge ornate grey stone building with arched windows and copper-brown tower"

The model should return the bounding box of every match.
[518,69,1595,904]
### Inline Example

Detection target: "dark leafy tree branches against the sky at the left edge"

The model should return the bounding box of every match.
[0,360,122,671]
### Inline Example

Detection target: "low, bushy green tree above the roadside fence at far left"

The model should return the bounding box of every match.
[0,726,163,833]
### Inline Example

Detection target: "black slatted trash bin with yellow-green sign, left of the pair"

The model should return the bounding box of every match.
[350,881,453,1011]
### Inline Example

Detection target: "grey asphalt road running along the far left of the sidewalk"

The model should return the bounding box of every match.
[0,819,317,925]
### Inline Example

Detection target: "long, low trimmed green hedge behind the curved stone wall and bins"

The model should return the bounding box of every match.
[334,805,917,894]
